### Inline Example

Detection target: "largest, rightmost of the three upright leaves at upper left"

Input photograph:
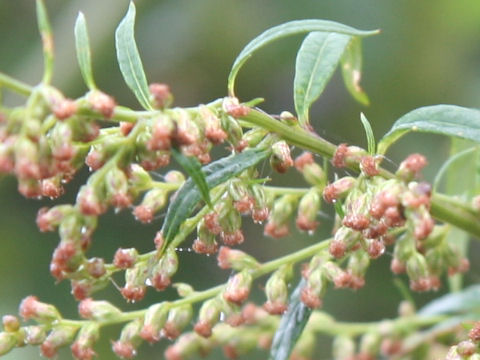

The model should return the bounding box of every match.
[115,1,153,110]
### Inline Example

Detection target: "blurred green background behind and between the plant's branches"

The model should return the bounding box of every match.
[0,0,480,359]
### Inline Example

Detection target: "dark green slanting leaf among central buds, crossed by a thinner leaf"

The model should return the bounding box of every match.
[162,149,270,248]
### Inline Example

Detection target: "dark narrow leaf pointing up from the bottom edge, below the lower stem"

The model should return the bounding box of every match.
[269,279,312,360]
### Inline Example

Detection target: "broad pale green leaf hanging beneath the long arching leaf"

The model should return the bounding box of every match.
[293,32,351,125]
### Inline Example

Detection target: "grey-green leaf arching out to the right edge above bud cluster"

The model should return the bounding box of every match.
[378,105,480,154]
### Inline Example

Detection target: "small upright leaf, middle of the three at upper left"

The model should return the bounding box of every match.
[75,12,97,90]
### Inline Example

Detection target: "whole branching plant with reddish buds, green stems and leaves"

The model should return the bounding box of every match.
[0,0,480,360]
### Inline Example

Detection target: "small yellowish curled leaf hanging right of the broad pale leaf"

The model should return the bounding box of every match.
[341,37,370,106]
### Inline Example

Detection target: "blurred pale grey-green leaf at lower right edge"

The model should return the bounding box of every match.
[418,285,480,316]
